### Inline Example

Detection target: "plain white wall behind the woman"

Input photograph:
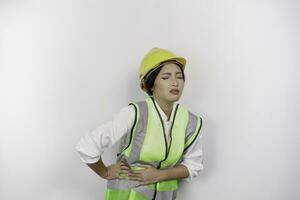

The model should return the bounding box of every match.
[0,0,300,200]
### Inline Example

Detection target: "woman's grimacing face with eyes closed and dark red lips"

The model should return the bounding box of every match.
[153,63,184,103]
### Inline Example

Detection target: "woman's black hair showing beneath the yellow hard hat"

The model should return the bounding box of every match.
[144,61,185,96]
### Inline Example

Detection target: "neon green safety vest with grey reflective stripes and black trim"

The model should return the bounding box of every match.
[105,97,202,200]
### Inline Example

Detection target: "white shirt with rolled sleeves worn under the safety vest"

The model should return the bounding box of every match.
[75,101,203,180]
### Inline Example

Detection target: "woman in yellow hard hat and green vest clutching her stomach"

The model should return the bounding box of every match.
[76,48,203,200]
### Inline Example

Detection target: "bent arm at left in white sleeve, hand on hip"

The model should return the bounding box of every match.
[75,106,135,179]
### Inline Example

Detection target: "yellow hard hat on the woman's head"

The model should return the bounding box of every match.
[139,47,186,92]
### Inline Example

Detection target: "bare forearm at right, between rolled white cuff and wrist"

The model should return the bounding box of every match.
[159,165,189,181]
